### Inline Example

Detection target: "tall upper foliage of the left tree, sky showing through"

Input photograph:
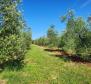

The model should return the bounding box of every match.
[0,0,24,37]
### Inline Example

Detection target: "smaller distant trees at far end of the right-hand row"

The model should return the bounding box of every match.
[33,25,58,48]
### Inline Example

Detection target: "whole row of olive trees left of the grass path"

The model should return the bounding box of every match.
[0,0,31,69]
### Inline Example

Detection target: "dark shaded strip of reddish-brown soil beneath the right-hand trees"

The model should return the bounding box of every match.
[44,49,91,66]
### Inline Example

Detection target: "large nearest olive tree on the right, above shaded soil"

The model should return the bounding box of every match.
[60,12,91,60]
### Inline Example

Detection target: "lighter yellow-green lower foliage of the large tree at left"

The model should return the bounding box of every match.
[0,35,25,64]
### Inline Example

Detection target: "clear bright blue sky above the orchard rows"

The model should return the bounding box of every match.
[23,0,91,39]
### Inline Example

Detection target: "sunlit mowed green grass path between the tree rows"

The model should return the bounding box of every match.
[0,45,91,84]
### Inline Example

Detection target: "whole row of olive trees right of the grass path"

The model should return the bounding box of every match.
[33,10,91,61]
